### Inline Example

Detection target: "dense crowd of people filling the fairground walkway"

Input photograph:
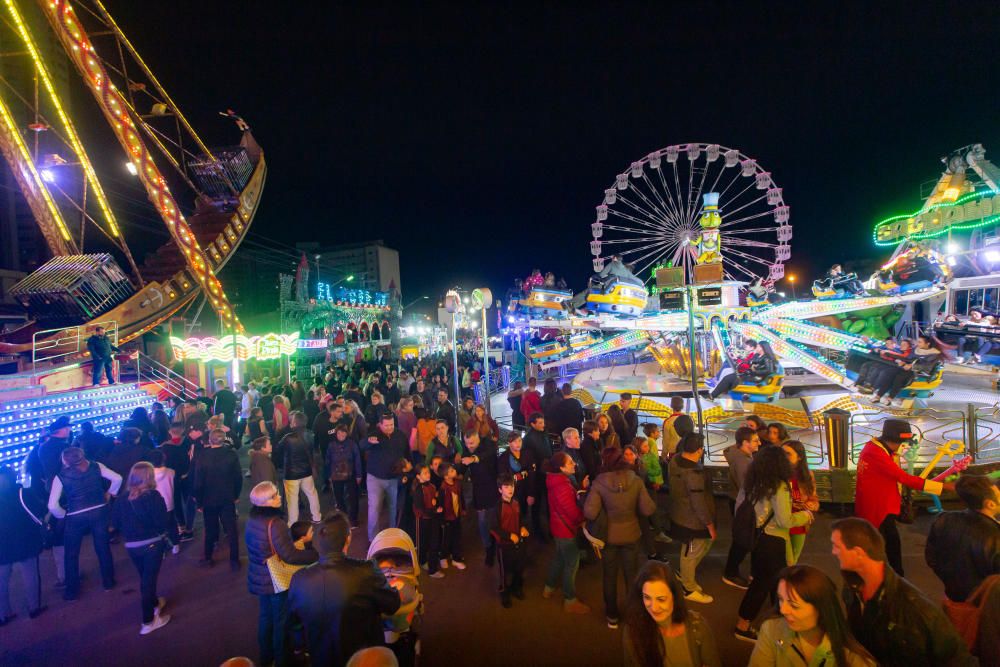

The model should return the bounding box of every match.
[0,350,1000,666]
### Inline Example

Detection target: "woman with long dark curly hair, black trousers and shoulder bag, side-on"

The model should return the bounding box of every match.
[734,447,813,642]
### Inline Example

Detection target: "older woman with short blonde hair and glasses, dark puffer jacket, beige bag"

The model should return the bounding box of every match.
[246,482,319,667]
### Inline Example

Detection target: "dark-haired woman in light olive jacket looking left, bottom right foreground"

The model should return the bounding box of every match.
[749,565,875,667]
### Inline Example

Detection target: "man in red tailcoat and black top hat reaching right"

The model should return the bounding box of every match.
[854,419,955,576]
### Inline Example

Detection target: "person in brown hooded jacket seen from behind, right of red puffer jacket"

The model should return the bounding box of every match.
[583,447,656,629]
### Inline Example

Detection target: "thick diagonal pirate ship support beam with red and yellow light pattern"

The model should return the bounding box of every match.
[39,0,243,331]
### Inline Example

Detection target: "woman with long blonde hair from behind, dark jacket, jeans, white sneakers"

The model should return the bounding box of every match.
[113,461,170,635]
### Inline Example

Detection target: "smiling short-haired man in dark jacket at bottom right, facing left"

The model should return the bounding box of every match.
[830,517,977,667]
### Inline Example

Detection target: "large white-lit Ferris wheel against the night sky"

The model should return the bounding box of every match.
[590,143,792,285]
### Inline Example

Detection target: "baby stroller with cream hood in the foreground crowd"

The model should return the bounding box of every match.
[368,528,424,667]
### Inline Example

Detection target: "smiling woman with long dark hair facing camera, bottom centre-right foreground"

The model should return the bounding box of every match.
[622,560,722,667]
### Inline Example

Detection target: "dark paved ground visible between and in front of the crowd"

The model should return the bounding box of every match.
[0,454,943,667]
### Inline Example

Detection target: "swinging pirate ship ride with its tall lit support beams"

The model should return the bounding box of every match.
[0,0,267,354]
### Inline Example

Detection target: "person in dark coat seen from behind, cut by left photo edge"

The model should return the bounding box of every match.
[0,468,46,626]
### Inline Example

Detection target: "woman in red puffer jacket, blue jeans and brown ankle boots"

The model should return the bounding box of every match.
[542,452,590,614]
